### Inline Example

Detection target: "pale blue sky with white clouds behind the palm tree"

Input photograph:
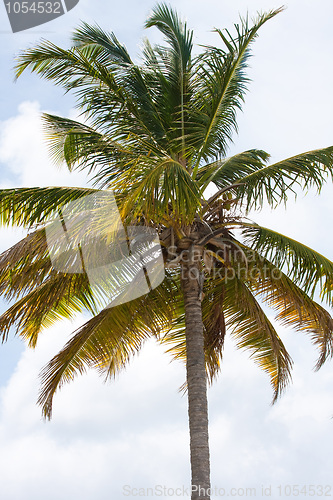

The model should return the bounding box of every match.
[0,0,333,500]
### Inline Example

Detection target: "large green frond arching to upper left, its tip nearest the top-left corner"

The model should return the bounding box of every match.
[16,31,164,152]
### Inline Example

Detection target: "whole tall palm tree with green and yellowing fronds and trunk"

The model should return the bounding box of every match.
[0,4,333,500]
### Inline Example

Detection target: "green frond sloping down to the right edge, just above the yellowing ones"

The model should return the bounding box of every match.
[243,223,333,305]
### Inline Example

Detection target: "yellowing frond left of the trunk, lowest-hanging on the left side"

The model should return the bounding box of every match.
[39,270,177,418]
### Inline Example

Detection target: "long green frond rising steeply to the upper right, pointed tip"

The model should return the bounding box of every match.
[193,9,282,172]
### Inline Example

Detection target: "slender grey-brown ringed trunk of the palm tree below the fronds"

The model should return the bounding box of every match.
[182,262,210,500]
